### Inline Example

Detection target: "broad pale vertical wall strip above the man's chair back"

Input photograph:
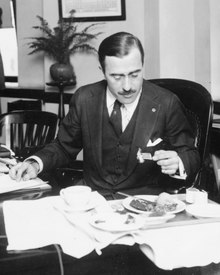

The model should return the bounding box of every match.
[159,0,195,80]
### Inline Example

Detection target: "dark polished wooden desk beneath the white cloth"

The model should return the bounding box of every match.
[0,189,220,275]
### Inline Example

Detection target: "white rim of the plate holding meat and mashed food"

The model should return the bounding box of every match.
[123,195,186,215]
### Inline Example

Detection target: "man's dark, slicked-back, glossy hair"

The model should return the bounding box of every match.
[98,32,144,71]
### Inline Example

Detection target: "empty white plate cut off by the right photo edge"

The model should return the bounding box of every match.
[186,203,220,218]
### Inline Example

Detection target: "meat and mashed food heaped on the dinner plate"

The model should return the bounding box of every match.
[130,192,177,216]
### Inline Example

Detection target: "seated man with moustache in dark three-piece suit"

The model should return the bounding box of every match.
[10,32,200,194]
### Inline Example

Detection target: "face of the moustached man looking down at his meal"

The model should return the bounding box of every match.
[104,48,143,104]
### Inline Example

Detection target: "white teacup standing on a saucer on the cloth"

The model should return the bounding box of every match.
[60,185,92,208]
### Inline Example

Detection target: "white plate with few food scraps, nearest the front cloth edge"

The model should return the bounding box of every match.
[89,213,145,232]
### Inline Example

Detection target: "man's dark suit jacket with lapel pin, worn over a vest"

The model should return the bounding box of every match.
[36,80,200,193]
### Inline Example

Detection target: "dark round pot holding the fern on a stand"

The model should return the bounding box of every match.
[50,63,76,81]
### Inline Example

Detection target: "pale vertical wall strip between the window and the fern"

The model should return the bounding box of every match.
[16,0,44,88]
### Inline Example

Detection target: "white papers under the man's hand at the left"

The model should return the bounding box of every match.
[0,174,51,194]
